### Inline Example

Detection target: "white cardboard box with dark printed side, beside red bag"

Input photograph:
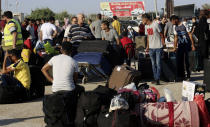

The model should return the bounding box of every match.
[182,81,206,101]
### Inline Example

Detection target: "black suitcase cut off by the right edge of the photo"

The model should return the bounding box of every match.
[204,59,210,92]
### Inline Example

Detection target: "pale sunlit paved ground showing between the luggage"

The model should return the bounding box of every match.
[0,73,210,127]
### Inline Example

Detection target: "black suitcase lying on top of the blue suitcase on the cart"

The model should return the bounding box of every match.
[77,40,109,53]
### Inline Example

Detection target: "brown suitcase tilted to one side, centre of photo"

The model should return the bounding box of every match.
[108,65,141,90]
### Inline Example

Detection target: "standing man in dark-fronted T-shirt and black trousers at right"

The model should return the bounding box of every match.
[171,15,195,80]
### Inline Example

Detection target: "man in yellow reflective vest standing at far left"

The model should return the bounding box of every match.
[2,11,23,51]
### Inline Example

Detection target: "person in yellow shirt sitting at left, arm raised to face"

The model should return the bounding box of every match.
[0,49,31,90]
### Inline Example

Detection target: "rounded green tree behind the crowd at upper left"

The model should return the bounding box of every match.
[28,8,55,19]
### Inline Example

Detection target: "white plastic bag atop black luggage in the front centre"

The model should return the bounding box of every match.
[109,94,129,112]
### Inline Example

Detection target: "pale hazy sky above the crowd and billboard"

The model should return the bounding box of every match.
[2,0,210,14]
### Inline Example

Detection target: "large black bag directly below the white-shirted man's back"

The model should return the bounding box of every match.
[43,91,77,127]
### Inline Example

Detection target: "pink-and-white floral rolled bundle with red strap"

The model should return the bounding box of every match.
[136,102,200,127]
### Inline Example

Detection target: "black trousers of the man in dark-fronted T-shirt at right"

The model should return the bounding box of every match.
[176,48,190,78]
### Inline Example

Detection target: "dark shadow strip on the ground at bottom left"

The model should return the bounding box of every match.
[0,116,44,126]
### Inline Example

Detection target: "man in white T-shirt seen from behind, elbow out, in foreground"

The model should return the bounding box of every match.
[42,42,78,92]
